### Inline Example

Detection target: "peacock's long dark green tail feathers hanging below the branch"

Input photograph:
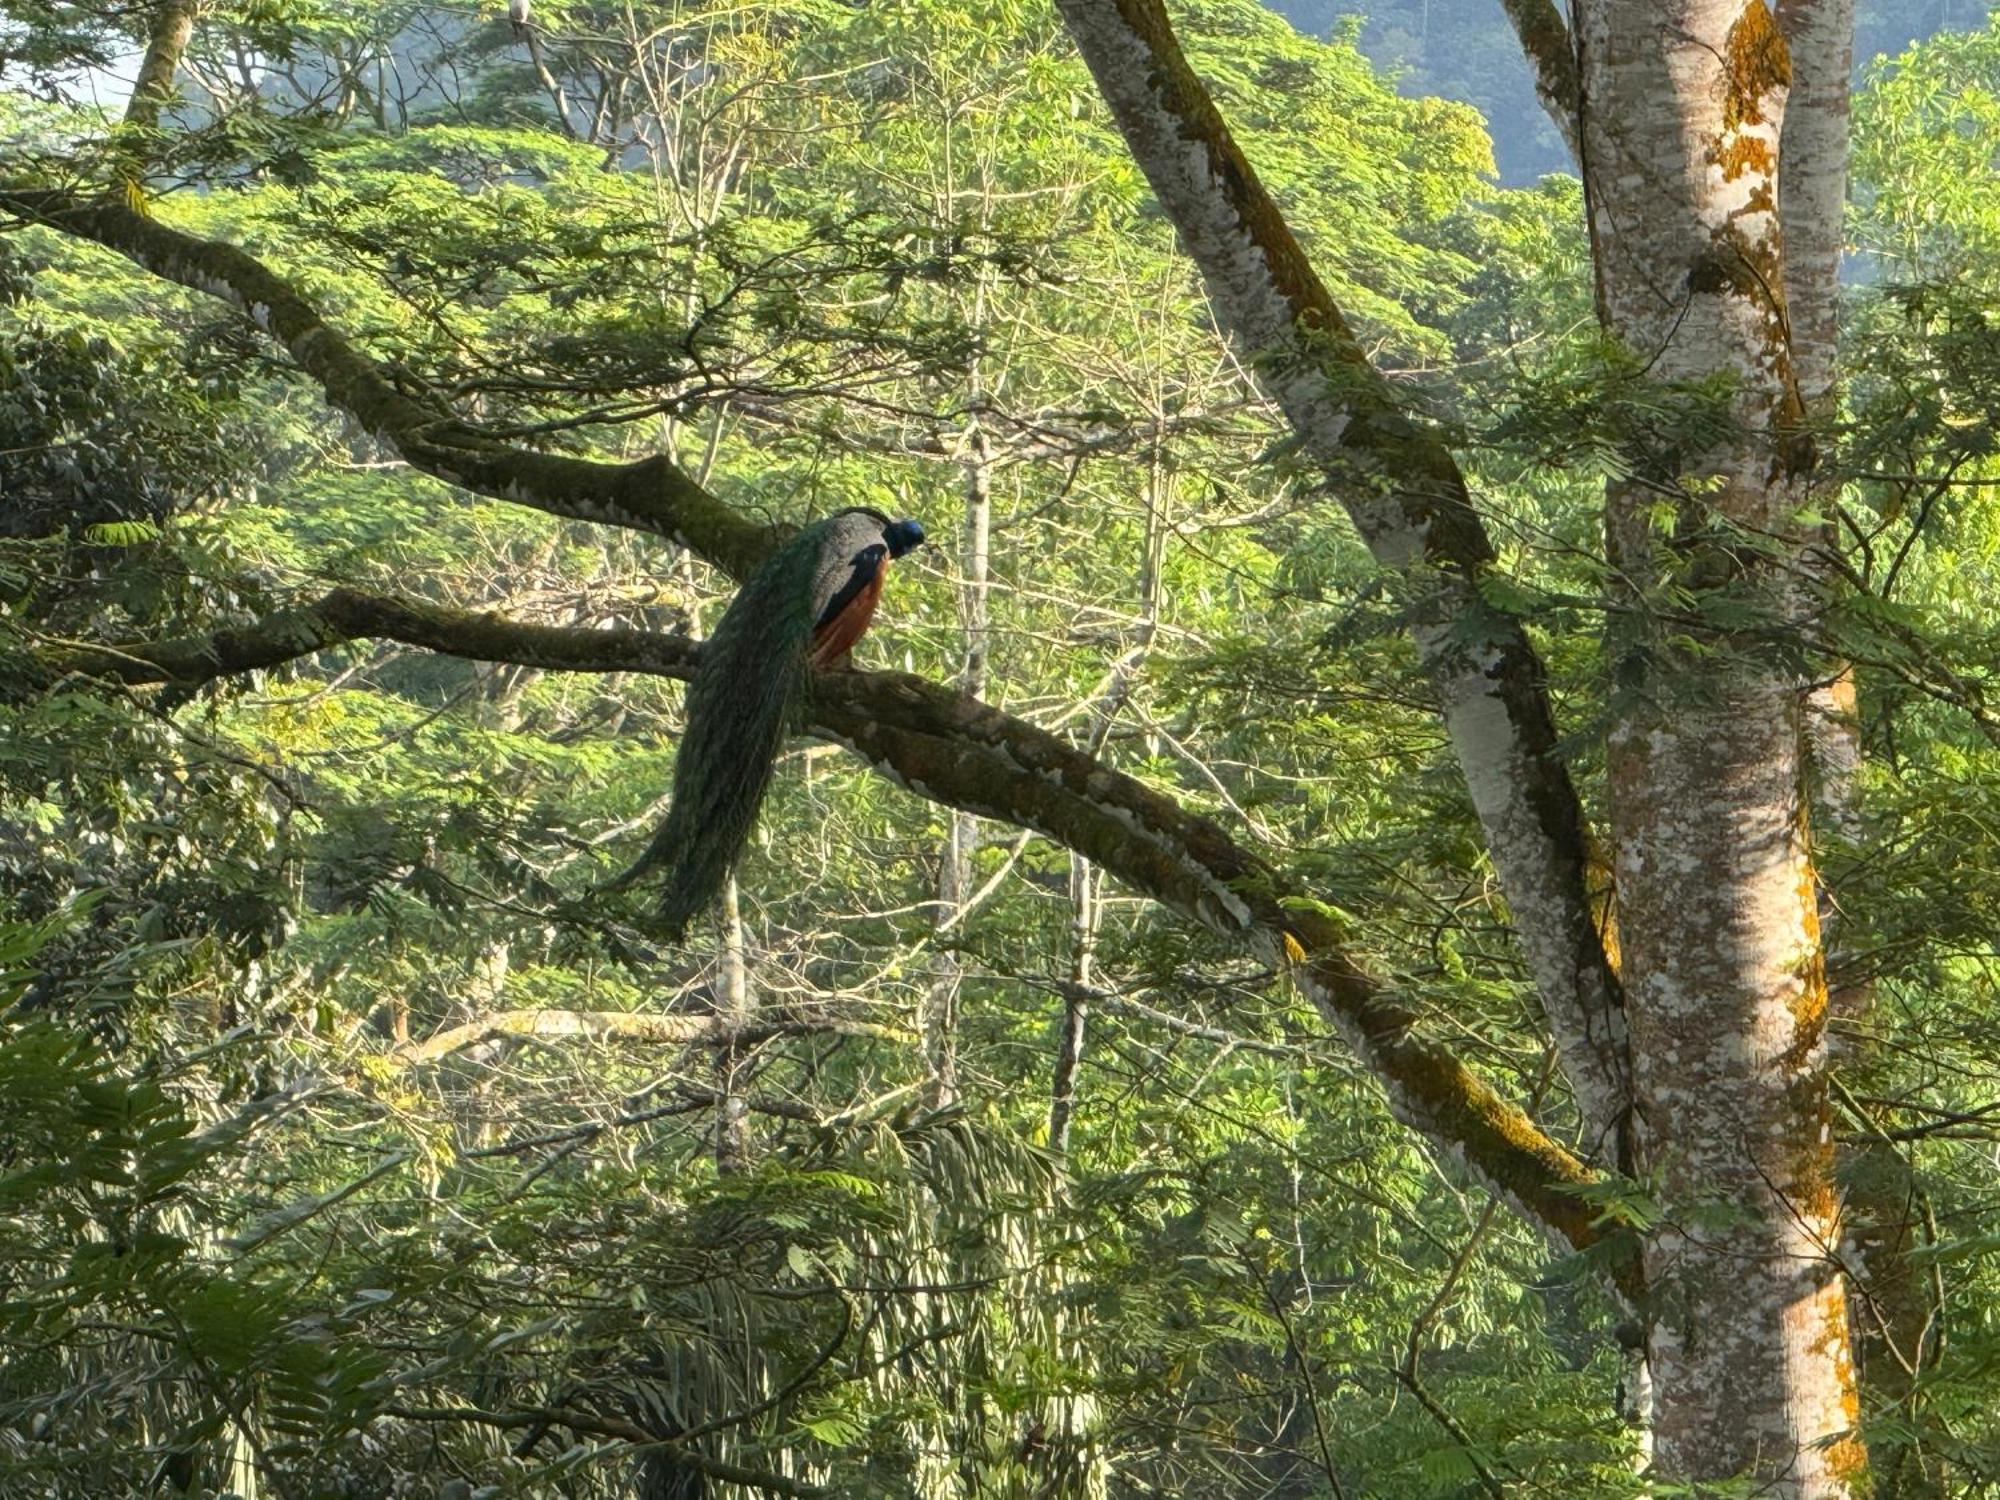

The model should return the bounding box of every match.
[636,522,832,942]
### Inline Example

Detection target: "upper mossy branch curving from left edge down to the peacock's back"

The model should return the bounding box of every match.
[0,186,772,578]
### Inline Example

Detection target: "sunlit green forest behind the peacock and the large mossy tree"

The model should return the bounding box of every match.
[0,0,2000,1500]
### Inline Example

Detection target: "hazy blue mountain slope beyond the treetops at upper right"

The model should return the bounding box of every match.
[1268,0,1986,184]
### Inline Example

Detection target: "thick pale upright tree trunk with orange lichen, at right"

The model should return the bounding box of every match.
[1578,0,1866,1498]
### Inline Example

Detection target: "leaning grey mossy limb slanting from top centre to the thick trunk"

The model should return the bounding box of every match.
[1058,0,1630,1158]
